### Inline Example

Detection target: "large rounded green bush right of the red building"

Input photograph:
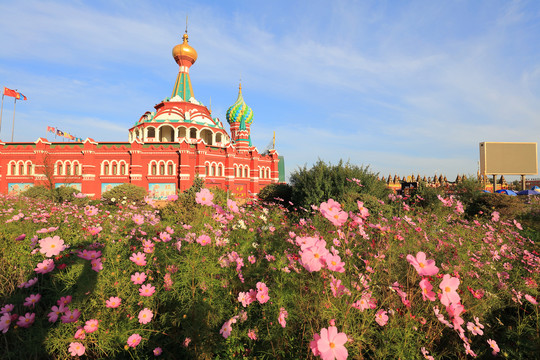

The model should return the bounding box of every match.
[290,160,390,209]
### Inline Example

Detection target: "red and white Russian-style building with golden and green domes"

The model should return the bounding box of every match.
[0,33,279,199]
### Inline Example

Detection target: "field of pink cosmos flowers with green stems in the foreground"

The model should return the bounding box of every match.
[0,189,540,359]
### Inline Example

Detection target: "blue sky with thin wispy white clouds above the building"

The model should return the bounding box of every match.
[0,0,540,181]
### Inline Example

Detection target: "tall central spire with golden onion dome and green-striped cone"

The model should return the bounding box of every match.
[171,30,197,101]
